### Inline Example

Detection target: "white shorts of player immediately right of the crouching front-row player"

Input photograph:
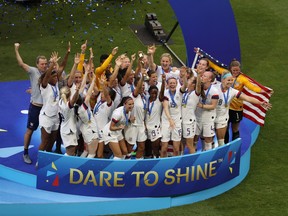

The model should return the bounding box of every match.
[124,125,147,145]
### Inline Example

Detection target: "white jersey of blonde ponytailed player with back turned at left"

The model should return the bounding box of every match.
[59,99,76,134]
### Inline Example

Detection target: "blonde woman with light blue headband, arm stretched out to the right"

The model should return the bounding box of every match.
[215,71,271,146]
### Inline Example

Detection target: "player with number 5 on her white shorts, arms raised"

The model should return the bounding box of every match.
[182,69,201,154]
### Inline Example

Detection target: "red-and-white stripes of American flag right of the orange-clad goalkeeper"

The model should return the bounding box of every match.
[242,74,273,126]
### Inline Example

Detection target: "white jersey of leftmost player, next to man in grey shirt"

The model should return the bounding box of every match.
[40,82,59,117]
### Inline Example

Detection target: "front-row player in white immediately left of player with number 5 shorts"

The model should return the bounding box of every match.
[161,77,186,157]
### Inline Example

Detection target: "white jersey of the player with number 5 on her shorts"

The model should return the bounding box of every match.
[182,91,199,124]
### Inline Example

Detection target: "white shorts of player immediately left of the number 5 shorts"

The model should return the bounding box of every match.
[161,122,182,142]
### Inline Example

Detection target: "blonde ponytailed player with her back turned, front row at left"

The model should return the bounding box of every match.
[59,84,80,156]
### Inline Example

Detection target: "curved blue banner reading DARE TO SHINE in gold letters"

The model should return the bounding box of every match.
[37,139,241,198]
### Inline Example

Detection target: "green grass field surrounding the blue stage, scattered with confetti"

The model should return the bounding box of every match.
[0,0,288,216]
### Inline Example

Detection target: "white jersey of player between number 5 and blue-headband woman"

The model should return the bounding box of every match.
[195,85,219,122]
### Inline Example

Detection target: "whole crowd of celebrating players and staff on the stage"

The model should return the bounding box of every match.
[15,41,271,163]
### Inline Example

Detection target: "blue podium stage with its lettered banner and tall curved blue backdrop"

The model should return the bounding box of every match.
[0,0,260,216]
